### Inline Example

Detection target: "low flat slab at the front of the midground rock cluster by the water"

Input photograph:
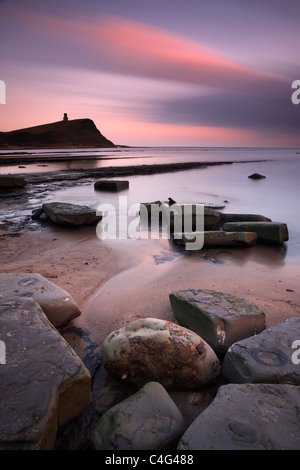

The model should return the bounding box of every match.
[172,230,257,246]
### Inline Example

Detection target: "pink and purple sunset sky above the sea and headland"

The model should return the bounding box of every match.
[0,0,300,147]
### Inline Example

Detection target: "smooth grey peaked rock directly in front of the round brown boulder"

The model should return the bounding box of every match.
[92,382,184,451]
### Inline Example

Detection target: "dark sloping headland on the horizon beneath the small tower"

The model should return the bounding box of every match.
[0,119,115,149]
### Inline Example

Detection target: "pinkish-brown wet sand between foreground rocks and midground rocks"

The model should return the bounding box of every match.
[0,225,300,344]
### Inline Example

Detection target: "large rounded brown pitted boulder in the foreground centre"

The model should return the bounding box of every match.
[101,318,220,390]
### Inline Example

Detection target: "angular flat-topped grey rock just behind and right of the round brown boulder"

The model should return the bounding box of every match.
[169,289,265,353]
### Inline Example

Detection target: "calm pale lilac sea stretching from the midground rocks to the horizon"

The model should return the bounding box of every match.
[0,147,300,263]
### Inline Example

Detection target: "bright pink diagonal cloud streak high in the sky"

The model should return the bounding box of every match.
[21,13,275,90]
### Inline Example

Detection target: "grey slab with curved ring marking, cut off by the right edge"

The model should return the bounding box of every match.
[222,317,300,386]
